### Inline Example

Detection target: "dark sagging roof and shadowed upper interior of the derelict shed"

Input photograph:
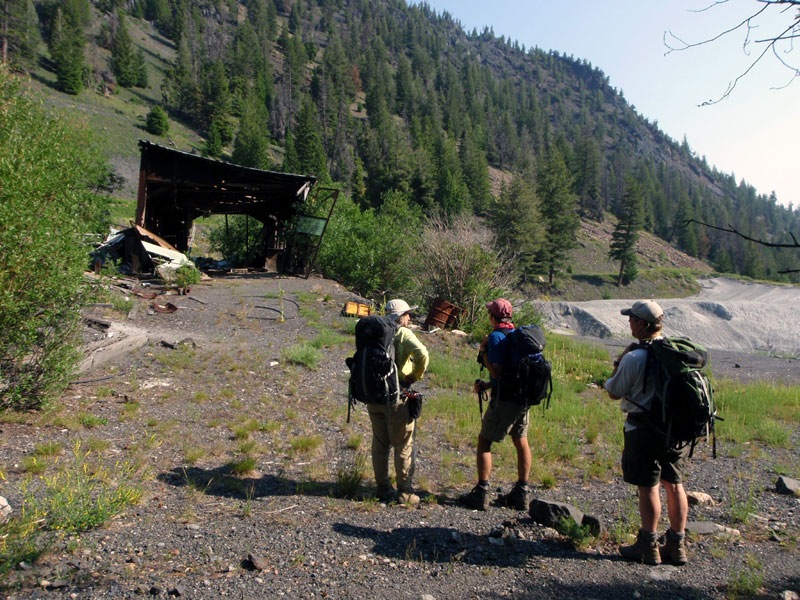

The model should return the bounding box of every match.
[136,140,317,252]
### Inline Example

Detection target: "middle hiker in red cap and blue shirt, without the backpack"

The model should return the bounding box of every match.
[459,298,531,510]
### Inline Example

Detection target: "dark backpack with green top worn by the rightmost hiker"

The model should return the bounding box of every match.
[639,337,722,458]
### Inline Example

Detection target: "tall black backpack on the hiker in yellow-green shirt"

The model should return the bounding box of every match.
[345,315,400,414]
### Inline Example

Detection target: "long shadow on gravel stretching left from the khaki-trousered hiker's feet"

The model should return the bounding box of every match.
[156,465,336,500]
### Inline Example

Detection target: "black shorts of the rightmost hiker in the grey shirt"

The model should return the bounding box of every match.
[622,426,689,487]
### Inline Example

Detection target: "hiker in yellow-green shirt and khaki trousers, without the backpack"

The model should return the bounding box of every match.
[367,299,428,504]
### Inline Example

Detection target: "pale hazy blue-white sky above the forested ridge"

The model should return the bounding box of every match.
[412,0,800,208]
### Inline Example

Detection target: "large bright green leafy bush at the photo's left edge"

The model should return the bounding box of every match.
[0,68,108,409]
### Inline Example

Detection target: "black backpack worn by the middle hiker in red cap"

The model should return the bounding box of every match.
[497,325,553,407]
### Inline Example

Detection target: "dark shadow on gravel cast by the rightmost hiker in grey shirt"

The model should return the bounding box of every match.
[332,523,622,567]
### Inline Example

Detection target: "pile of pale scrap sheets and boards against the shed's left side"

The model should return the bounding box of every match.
[92,222,194,281]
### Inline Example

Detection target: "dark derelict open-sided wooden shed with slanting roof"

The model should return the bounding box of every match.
[136,140,338,275]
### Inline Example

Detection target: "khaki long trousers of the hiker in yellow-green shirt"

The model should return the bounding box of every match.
[367,400,415,492]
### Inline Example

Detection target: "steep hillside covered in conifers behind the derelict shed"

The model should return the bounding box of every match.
[0,0,800,290]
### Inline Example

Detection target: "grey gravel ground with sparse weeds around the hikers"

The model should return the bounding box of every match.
[0,276,800,600]
